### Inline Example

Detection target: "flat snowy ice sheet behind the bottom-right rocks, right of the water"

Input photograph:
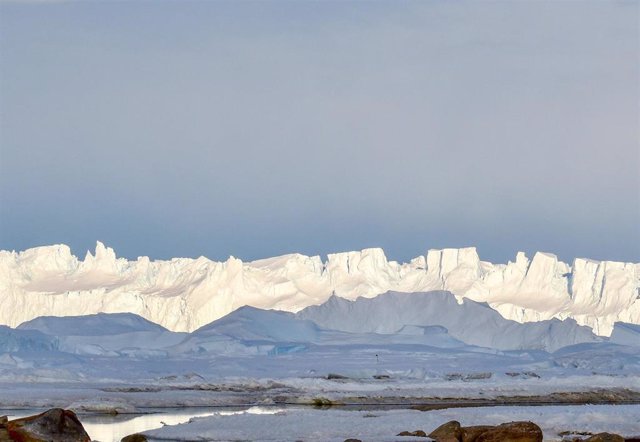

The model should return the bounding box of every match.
[141,405,640,442]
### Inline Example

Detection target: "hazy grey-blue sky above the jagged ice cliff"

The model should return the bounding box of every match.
[0,0,640,262]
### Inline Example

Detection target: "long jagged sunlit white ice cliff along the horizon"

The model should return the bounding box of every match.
[0,243,640,335]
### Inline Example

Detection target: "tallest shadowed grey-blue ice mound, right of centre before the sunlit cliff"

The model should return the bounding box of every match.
[297,292,601,351]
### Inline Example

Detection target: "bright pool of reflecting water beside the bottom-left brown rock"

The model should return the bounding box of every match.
[0,408,224,442]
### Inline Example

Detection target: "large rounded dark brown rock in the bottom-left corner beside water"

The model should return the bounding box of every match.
[7,408,91,442]
